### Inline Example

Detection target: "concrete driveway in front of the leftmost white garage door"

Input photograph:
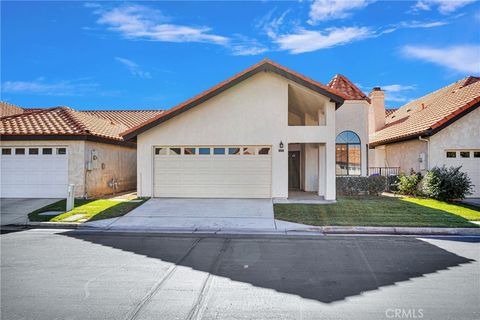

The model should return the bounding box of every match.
[0,198,60,226]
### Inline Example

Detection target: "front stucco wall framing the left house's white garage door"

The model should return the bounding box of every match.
[0,140,85,197]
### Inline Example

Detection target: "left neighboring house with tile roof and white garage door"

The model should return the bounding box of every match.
[0,103,161,198]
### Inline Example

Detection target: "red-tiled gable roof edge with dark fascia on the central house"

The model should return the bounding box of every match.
[122,59,348,139]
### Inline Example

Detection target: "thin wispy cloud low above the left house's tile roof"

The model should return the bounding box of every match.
[2,78,98,96]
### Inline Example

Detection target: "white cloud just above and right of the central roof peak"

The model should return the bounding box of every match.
[274,27,374,54]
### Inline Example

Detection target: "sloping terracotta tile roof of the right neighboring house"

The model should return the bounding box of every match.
[370,77,480,146]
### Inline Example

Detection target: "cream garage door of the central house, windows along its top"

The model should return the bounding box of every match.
[154,146,272,198]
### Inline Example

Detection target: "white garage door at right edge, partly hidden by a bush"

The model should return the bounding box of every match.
[445,150,480,198]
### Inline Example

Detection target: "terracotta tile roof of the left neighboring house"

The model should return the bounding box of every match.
[0,107,161,141]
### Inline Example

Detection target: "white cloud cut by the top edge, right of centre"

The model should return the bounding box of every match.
[308,0,374,24]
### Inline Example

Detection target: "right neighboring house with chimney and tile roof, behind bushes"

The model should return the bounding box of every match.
[369,76,480,197]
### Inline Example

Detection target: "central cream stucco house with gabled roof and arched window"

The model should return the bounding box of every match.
[122,60,370,200]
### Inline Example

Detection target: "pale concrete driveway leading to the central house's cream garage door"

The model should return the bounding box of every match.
[85,198,275,230]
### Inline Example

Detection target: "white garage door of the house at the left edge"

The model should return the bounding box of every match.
[0,146,68,198]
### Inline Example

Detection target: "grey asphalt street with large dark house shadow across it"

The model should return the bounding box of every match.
[1,229,480,320]
